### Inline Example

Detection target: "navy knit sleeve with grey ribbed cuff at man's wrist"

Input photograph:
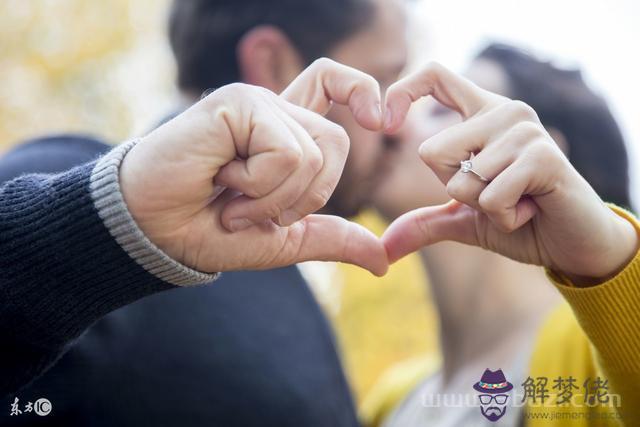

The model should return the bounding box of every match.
[0,140,215,354]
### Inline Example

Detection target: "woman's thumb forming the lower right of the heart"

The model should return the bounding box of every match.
[382,200,477,263]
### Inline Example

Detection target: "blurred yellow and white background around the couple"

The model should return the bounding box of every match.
[0,0,640,404]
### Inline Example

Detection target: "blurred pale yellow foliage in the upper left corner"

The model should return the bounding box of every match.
[0,0,170,148]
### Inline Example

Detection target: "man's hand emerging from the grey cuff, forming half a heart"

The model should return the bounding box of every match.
[120,60,388,275]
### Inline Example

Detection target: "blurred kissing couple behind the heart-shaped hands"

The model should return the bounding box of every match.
[0,0,640,427]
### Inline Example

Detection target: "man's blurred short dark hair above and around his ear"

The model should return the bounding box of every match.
[169,0,374,93]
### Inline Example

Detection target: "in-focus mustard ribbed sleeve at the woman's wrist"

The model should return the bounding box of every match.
[547,206,640,373]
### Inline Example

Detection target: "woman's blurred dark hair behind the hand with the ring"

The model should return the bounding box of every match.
[476,44,631,208]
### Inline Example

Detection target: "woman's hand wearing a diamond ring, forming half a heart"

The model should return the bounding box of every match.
[382,64,638,283]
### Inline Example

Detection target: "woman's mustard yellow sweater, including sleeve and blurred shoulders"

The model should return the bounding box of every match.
[361,207,640,427]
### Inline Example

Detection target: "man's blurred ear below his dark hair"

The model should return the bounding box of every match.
[237,25,303,93]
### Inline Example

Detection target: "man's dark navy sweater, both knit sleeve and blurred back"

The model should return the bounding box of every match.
[0,141,357,426]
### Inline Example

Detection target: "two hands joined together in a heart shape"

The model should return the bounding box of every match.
[120,59,637,284]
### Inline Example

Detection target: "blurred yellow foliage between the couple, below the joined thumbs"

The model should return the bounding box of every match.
[329,212,438,401]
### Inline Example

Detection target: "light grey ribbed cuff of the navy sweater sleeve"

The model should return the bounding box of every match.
[91,140,218,286]
